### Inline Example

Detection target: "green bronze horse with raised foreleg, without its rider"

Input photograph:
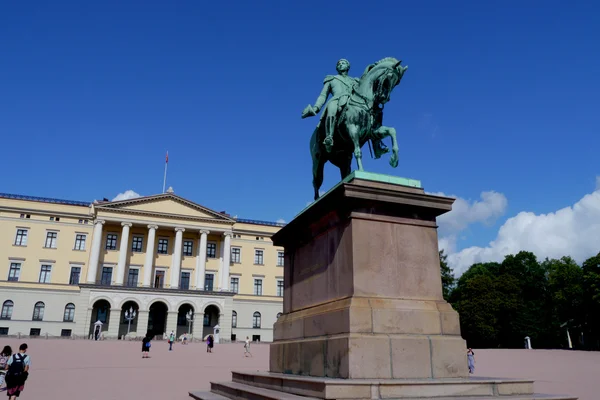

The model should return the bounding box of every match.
[310,57,408,200]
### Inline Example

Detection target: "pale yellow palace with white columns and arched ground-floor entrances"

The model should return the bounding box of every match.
[0,189,284,342]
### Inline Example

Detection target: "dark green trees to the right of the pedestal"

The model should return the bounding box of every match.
[440,250,600,350]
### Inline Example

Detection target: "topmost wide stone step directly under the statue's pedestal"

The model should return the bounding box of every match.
[232,371,533,400]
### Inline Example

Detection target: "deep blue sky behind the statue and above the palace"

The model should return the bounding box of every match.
[0,1,600,270]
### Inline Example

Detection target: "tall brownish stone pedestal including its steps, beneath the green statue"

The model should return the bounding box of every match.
[190,172,574,400]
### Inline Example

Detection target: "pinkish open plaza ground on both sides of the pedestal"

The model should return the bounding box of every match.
[0,339,600,400]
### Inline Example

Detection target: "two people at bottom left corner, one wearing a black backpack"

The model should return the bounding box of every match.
[0,343,31,400]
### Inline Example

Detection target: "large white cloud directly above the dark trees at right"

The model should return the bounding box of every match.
[448,184,600,275]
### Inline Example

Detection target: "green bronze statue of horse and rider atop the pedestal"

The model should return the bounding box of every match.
[302,57,408,200]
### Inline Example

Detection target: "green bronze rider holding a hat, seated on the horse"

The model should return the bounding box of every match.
[302,58,389,158]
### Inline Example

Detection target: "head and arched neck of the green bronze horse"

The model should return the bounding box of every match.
[361,57,408,104]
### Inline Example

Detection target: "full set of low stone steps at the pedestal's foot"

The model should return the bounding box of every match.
[190,372,577,400]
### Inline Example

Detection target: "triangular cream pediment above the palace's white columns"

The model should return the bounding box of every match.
[96,193,234,222]
